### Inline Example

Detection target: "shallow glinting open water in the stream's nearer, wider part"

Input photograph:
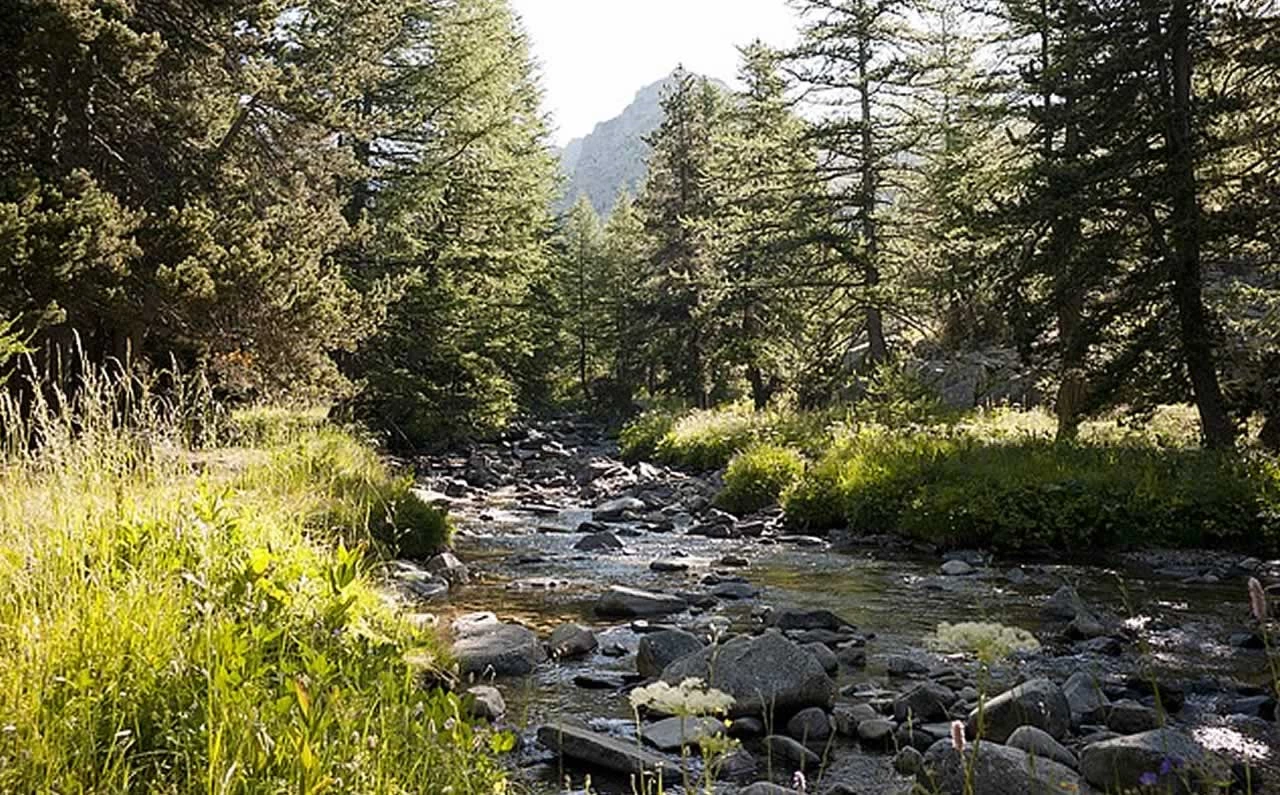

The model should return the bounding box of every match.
[432,489,1275,792]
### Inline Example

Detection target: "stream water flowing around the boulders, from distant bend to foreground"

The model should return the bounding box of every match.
[401,421,1280,792]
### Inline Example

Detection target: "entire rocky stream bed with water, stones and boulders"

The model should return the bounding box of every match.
[390,420,1280,795]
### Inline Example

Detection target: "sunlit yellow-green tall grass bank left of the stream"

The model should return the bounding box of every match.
[0,381,502,792]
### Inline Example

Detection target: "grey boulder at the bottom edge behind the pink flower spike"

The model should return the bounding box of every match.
[916,740,1080,795]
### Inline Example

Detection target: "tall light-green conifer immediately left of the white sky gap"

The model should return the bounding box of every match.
[349,0,562,444]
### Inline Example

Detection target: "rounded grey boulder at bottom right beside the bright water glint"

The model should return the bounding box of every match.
[1080,728,1231,792]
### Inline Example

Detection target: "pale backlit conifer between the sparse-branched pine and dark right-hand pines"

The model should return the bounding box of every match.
[896,0,1016,351]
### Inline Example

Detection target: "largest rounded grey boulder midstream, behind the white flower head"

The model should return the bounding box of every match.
[662,631,836,717]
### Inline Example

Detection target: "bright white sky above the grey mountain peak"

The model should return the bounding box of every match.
[512,0,796,146]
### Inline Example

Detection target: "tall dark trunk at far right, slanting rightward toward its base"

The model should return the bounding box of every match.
[1166,0,1235,448]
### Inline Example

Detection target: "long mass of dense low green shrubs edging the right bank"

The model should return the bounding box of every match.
[783,430,1277,552]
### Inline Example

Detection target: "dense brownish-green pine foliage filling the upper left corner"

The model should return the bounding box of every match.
[0,0,384,390]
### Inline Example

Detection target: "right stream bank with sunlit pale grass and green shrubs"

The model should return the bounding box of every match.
[622,407,1280,552]
